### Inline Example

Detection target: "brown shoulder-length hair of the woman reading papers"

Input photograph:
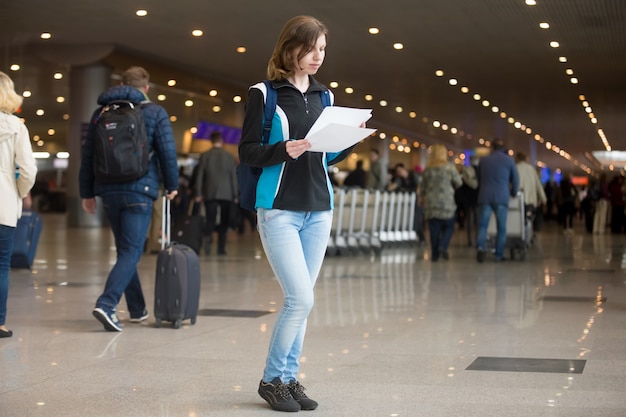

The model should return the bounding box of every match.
[267,16,328,81]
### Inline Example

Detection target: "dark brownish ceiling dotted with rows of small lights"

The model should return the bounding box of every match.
[0,0,626,174]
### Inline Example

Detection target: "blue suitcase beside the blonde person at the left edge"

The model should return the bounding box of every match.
[11,210,42,269]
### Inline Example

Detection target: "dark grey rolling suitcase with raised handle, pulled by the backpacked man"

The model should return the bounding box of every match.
[154,197,200,329]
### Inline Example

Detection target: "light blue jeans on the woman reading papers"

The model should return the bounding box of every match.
[258,209,332,383]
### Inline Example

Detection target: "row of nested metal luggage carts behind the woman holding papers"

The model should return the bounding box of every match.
[326,188,418,256]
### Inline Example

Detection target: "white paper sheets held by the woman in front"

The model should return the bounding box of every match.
[305,106,376,152]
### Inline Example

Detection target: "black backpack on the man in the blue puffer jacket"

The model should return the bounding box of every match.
[94,100,150,184]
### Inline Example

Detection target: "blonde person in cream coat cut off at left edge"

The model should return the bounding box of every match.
[0,72,37,338]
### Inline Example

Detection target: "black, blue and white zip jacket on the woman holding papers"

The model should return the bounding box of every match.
[239,77,353,211]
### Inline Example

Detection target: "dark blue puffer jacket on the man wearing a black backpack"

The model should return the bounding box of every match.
[79,85,178,200]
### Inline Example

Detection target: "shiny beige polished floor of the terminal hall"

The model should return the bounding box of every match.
[0,214,626,417]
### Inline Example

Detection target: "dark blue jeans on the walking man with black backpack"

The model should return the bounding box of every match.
[96,192,152,317]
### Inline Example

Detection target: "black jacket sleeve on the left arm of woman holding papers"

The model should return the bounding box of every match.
[239,88,294,168]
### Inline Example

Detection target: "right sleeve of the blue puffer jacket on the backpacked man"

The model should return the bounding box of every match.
[153,106,178,191]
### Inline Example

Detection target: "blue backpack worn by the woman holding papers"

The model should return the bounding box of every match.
[237,80,331,211]
